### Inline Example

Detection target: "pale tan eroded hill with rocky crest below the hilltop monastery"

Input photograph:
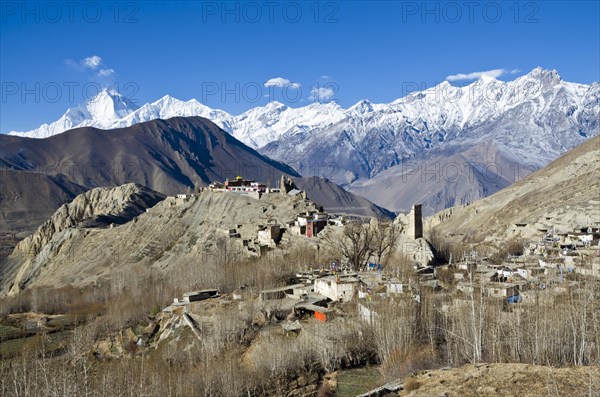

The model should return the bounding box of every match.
[0,185,324,293]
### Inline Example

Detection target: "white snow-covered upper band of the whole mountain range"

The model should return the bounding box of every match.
[8,68,600,154]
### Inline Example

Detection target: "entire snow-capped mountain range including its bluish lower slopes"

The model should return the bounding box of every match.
[10,68,600,213]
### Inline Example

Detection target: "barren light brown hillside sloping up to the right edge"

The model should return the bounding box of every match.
[426,137,600,241]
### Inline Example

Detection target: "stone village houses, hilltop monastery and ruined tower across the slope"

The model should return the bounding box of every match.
[154,177,600,370]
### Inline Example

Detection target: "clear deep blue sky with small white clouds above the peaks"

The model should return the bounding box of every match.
[0,1,600,133]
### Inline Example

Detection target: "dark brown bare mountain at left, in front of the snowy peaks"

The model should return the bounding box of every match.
[0,117,391,255]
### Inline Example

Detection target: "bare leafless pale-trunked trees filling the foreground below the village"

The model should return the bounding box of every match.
[0,230,600,396]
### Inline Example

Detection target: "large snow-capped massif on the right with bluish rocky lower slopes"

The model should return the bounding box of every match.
[260,68,600,185]
